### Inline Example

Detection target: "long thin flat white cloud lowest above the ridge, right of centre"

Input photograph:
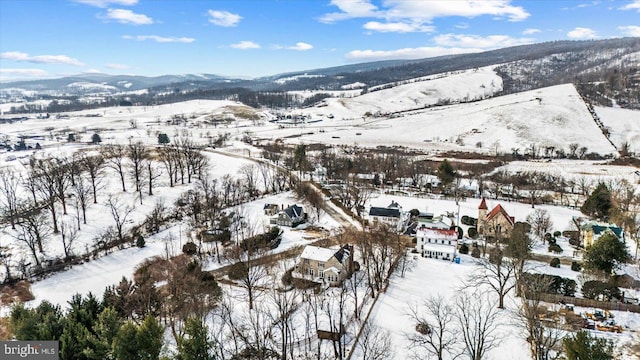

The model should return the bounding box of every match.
[346,46,482,61]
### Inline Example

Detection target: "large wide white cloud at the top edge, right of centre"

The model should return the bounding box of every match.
[319,0,530,24]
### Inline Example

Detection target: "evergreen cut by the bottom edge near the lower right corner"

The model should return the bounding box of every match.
[563,331,613,360]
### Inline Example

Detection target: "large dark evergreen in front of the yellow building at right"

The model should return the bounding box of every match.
[583,232,631,274]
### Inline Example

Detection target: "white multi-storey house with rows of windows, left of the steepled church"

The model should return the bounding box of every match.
[416,226,458,261]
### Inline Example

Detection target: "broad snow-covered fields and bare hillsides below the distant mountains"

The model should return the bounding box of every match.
[0,68,640,155]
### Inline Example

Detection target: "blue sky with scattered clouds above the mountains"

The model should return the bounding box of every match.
[0,0,640,82]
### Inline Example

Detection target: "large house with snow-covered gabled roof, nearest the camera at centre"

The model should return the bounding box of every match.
[291,245,353,286]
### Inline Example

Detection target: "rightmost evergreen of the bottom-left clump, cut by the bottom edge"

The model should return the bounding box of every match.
[177,318,215,360]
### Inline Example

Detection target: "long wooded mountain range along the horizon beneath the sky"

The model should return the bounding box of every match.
[0,37,640,109]
